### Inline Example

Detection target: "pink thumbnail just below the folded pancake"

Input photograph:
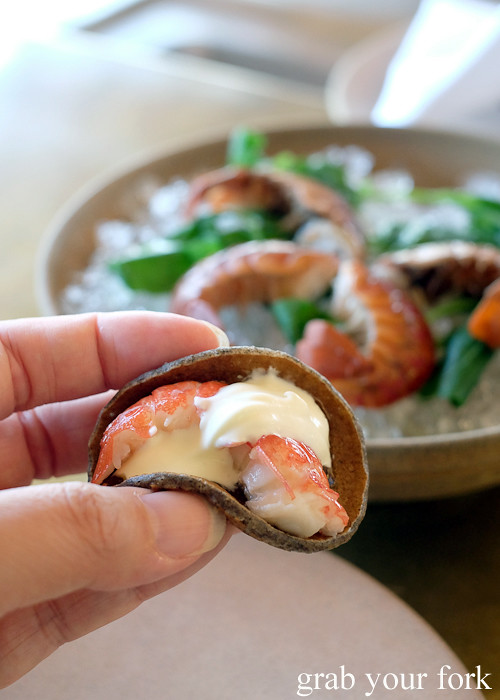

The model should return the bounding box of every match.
[141,491,226,559]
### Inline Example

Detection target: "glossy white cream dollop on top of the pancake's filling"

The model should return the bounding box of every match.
[195,370,331,467]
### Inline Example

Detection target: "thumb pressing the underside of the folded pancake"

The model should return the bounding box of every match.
[0,482,226,614]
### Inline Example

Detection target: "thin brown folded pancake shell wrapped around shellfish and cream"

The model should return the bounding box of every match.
[88,346,368,552]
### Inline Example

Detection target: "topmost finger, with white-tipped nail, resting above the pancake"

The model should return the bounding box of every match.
[0,311,227,419]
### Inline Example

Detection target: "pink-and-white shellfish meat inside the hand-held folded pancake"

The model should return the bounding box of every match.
[92,381,349,537]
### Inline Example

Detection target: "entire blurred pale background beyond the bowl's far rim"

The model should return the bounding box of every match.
[0,0,500,317]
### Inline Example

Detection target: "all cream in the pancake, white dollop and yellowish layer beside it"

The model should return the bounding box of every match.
[116,371,331,489]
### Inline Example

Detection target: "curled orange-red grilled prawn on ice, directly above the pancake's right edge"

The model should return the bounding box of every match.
[296,261,435,407]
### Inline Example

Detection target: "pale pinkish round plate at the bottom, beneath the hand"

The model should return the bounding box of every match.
[2,535,482,700]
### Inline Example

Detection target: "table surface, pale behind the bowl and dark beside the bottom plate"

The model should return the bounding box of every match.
[0,24,500,699]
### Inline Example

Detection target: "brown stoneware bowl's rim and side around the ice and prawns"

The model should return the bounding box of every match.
[36,125,500,501]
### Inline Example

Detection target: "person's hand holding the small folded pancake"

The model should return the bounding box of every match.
[0,312,230,687]
